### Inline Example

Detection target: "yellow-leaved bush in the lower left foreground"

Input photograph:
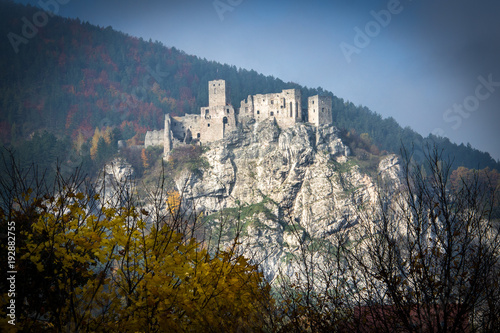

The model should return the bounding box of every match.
[0,188,271,332]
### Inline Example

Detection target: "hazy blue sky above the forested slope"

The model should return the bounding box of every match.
[10,0,500,160]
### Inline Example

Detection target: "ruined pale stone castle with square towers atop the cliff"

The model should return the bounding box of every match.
[144,80,332,158]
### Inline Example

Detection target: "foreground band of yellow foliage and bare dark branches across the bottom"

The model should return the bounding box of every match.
[0,149,500,333]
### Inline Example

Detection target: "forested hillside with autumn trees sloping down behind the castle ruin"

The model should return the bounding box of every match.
[0,1,500,174]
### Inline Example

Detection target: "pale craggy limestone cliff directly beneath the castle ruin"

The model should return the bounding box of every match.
[176,120,401,280]
